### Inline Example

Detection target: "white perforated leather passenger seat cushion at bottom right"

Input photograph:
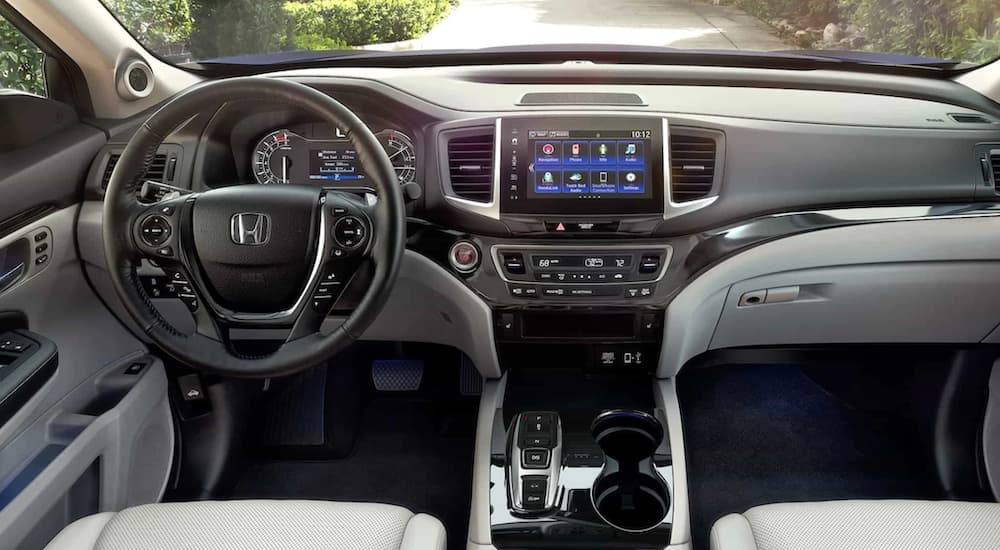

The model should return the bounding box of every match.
[711,500,1000,550]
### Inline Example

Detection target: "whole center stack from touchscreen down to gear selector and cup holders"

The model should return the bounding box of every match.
[443,113,700,550]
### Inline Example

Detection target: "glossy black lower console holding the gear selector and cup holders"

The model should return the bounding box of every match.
[489,369,684,550]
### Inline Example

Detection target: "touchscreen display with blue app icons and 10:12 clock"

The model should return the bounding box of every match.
[500,117,663,215]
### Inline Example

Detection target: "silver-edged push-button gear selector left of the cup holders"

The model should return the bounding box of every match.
[507,412,562,515]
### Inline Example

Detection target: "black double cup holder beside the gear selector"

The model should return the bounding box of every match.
[590,410,670,533]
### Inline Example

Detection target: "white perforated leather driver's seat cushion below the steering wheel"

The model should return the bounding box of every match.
[46,500,445,550]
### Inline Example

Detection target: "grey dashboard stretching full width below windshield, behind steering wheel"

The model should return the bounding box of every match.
[89,65,1000,376]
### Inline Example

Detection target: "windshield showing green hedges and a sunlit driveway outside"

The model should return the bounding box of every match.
[103,0,1000,65]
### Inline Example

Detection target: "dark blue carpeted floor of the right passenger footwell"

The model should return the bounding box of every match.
[678,366,942,550]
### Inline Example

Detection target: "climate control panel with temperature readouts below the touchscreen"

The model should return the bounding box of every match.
[492,245,672,301]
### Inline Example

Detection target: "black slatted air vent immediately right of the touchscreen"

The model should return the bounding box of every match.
[670,131,716,203]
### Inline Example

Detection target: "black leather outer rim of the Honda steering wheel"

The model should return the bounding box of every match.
[103,77,406,377]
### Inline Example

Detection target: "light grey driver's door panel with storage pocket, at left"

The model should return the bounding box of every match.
[0,94,174,550]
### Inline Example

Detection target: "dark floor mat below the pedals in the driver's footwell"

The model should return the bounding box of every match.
[233,398,476,550]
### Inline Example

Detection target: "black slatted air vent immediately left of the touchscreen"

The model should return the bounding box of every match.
[448,132,493,203]
